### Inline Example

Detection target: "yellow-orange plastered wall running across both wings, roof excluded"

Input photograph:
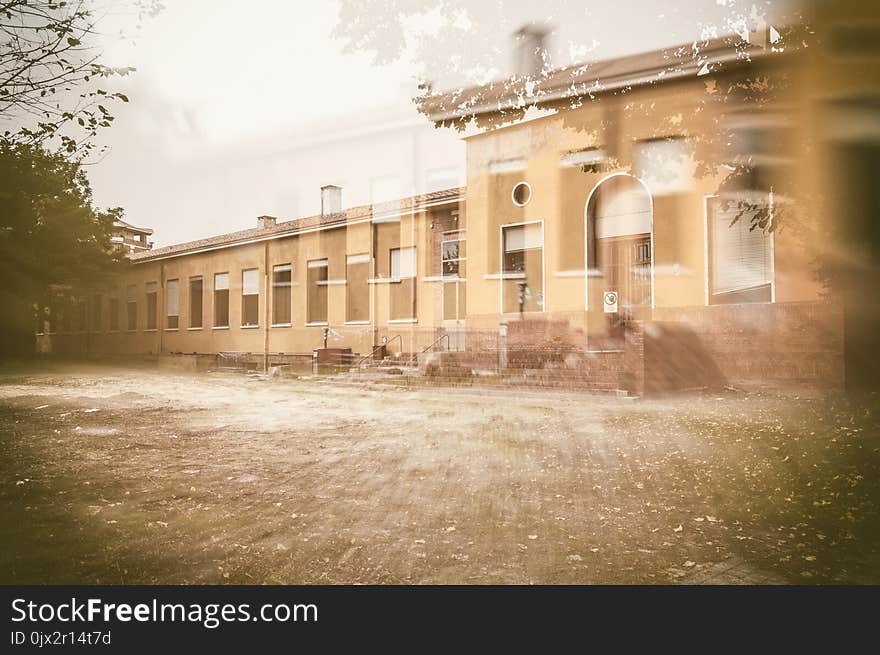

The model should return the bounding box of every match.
[42,26,856,394]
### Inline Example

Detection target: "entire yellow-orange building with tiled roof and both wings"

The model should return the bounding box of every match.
[38,10,880,391]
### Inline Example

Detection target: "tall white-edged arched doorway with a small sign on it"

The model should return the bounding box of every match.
[584,173,654,348]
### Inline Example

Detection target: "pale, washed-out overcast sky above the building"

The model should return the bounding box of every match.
[89,0,796,245]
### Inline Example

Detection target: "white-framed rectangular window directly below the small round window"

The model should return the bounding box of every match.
[501,223,544,313]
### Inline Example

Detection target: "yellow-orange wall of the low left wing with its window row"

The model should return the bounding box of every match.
[38,200,468,362]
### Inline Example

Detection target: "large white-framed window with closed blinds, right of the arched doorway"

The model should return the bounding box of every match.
[709,200,773,304]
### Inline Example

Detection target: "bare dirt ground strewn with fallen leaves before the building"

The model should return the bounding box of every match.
[0,365,880,584]
